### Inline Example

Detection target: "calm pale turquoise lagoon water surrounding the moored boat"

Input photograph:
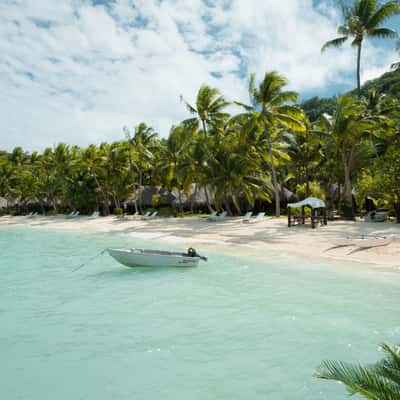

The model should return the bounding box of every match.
[0,228,400,400]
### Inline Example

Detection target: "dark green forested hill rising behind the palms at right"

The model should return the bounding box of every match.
[301,69,400,122]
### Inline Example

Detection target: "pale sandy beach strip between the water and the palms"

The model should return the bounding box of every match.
[0,216,400,270]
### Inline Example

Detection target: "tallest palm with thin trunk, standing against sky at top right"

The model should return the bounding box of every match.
[322,0,400,97]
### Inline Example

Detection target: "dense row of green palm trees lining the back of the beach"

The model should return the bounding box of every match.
[0,72,400,219]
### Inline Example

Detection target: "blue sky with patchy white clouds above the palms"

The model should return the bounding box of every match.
[0,0,400,151]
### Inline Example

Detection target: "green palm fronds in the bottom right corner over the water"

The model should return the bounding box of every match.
[315,344,400,400]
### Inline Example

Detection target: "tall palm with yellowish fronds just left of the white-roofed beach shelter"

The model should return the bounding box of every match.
[236,72,305,217]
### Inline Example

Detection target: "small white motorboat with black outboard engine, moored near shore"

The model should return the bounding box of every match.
[107,247,207,267]
